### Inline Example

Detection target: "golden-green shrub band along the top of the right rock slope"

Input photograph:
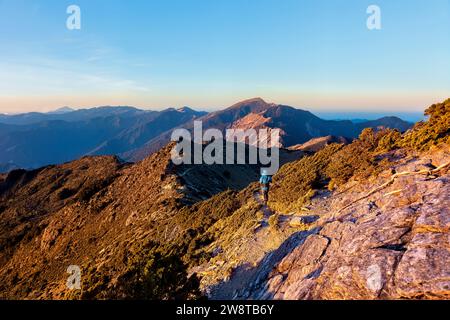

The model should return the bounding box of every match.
[269,99,450,211]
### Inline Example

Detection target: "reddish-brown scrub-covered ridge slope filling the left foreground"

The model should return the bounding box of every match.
[0,144,303,298]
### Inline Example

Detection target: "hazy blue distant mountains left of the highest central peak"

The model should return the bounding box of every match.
[0,107,205,168]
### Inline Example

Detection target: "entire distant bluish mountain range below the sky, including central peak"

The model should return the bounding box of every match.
[0,98,412,172]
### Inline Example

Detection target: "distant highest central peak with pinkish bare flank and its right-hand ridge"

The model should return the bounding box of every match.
[121,98,412,161]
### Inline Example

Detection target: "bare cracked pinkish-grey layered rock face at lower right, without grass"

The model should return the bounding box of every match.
[243,148,450,300]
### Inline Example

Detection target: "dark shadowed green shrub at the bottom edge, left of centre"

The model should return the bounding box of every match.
[80,242,201,300]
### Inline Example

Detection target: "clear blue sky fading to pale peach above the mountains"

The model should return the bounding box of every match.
[0,0,450,113]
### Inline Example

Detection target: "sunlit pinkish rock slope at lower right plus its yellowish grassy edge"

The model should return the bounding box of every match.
[200,147,450,300]
